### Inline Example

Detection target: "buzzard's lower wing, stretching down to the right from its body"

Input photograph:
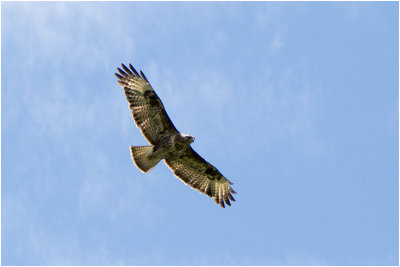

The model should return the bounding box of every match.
[165,147,236,208]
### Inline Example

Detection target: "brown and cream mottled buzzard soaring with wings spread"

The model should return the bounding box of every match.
[115,64,236,208]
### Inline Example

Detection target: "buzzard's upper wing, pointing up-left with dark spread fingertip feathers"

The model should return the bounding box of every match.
[115,64,178,145]
